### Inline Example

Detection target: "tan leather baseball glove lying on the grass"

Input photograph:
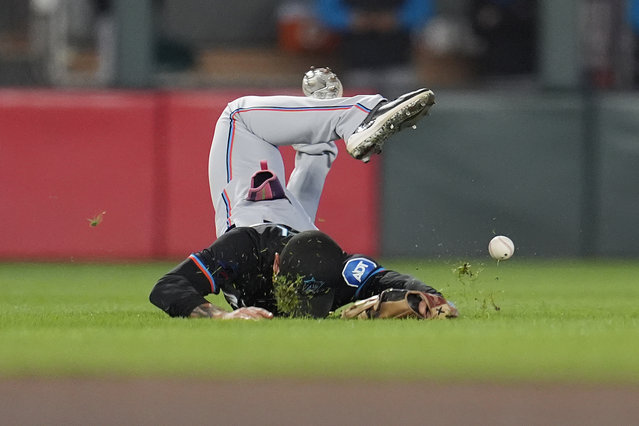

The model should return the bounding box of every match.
[342,289,459,319]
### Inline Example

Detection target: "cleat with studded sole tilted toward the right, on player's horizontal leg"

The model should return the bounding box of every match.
[346,89,435,163]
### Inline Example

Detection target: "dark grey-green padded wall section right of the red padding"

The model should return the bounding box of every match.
[381,92,639,257]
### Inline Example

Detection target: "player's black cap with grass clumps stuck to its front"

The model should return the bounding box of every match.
[276,231,346,318]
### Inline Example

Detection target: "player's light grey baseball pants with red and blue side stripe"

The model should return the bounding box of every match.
[209,95,384,237]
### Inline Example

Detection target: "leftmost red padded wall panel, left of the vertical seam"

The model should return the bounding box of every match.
[0,91,155,260]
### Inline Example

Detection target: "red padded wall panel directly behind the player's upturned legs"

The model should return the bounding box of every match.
[165,91,379,256]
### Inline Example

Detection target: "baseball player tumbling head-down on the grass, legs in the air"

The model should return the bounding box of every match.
[150,69,457,319]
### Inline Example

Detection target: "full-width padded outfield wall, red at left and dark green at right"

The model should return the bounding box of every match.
[0,90,639,260]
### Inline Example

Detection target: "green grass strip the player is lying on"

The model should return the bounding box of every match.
[0,258,639,384]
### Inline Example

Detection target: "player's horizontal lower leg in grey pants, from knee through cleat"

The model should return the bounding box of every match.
[230,89,435,162]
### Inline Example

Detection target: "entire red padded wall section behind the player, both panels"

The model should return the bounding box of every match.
[0,90,379,260]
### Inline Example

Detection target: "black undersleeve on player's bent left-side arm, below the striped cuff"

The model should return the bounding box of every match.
[149,257,211,317]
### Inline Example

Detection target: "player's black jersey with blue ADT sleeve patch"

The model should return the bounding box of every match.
[149,223,440,317]
